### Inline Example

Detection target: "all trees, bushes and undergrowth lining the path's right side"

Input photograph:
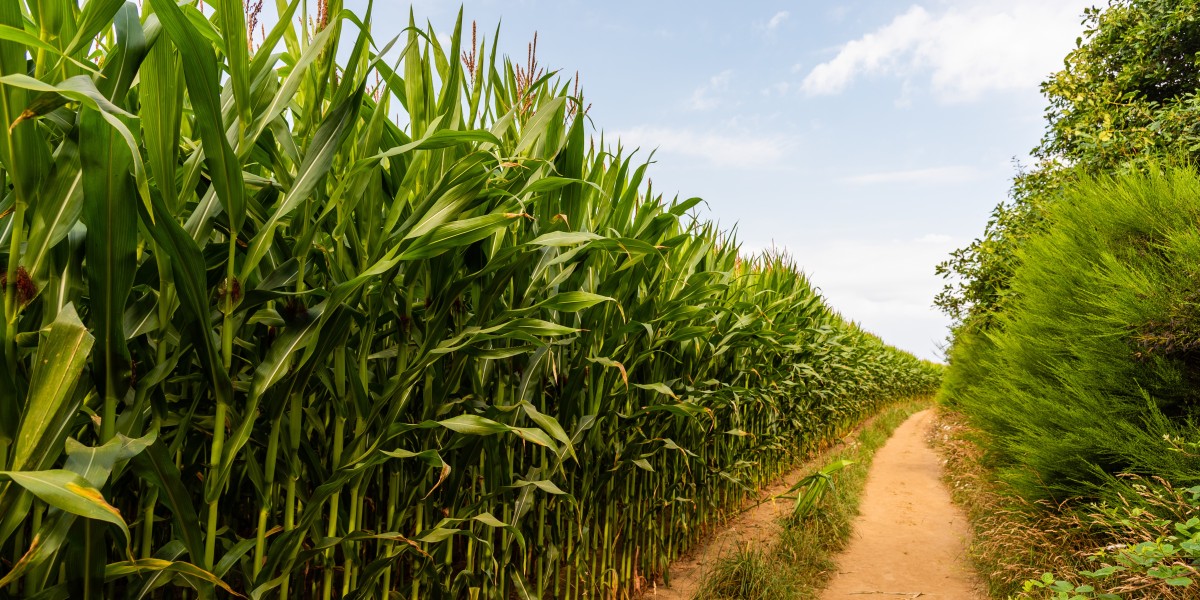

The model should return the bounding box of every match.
[938,0,1200,599]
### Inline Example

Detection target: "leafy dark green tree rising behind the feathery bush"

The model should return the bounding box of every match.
[936,0,1200,330]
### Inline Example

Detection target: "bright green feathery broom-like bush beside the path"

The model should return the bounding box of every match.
[943,169,1200,502]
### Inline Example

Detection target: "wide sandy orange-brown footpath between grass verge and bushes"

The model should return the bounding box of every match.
[821,410,985,600]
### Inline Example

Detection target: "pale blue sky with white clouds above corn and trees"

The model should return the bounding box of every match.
[316,0,1093,360]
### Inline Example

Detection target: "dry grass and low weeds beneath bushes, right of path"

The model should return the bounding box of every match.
[935,407,1200,600]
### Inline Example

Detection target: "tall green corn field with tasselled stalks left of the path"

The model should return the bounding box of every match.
[0,0,940,599]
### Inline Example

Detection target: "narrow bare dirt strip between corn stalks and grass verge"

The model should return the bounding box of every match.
[646,419,874,600]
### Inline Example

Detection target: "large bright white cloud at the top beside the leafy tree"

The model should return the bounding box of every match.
[803,0,1093,102]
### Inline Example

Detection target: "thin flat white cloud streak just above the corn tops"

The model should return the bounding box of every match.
[612,126,792,168]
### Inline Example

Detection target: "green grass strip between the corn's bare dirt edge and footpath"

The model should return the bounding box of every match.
[695,397,930,600]
